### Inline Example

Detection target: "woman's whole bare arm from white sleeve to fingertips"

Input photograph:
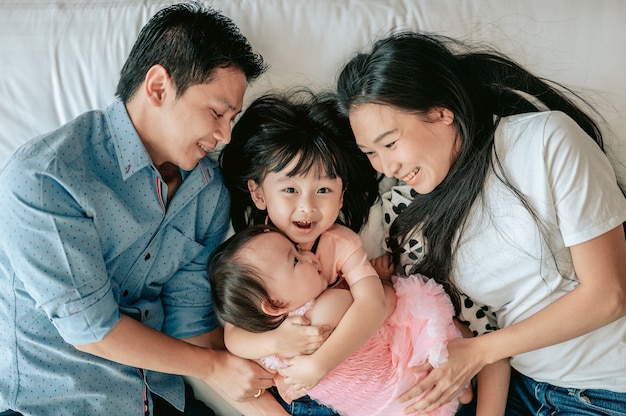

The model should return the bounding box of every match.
[399,224,626,412]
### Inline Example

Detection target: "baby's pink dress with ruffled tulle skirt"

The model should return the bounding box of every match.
[262,275,461,416]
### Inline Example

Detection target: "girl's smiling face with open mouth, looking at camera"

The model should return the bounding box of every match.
[248,158,344,248]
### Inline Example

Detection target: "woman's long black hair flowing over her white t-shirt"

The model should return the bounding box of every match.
[337,32,616,311]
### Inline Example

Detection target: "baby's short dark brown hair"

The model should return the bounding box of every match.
[207,225,287,332]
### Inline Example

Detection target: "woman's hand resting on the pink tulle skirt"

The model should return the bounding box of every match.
[398,338,486,414]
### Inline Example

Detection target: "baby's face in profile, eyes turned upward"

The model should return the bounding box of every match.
[242,232,328,310]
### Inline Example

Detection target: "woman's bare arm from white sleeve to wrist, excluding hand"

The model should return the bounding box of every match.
[476,225,626,368]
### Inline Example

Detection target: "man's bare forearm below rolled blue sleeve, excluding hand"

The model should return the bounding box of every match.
[75,315,216,378]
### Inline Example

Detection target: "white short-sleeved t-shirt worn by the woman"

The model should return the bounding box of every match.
[453,112,626,392]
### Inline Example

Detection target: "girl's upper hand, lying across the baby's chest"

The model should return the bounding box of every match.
[274,316,332,357]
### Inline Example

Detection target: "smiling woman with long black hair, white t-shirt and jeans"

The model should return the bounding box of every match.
[338,33,626,414]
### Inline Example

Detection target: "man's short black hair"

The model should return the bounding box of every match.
[115,1,266,103]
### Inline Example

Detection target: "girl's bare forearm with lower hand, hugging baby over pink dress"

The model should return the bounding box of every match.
[279,275,395,390]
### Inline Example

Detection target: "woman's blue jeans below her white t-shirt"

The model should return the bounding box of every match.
[506,370,626,416]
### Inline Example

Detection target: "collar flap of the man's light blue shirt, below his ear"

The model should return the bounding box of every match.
[106,99,152,180]
